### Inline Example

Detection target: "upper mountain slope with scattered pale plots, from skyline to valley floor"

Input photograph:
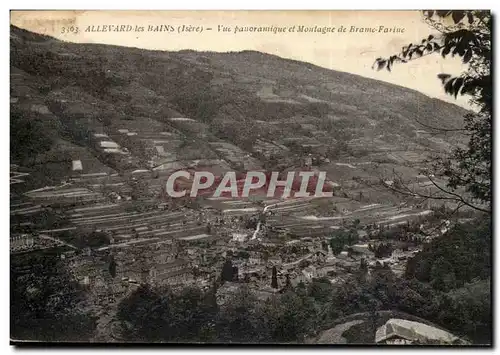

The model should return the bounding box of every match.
[10,27,465,192]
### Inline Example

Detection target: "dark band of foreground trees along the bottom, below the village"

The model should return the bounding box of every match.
[11,220,491,343]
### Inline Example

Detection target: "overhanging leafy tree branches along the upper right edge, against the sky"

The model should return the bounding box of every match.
[374,10,493,213]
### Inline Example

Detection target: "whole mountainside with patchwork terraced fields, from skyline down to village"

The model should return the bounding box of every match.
[10,27,464,254]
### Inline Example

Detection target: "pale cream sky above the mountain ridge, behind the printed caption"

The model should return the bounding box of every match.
[11,10,468,107]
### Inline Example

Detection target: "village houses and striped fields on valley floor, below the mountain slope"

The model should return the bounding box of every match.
[11,144,446,314]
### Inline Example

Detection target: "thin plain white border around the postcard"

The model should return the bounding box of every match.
[0,0,500,355]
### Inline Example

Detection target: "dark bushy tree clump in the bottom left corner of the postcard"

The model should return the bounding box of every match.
[10,253,96,341]
